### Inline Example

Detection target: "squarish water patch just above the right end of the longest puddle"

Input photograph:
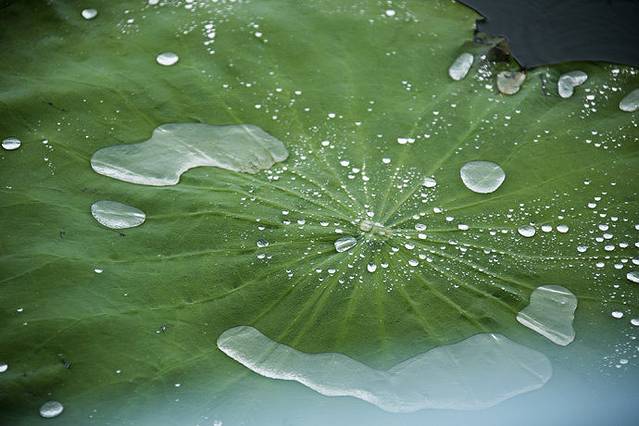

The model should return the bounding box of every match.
[517,285,577,346]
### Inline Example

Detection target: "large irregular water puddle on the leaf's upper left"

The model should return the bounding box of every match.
[91,123,288,186]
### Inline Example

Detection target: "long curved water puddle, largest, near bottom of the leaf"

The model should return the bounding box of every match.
[217,326,552,412]
